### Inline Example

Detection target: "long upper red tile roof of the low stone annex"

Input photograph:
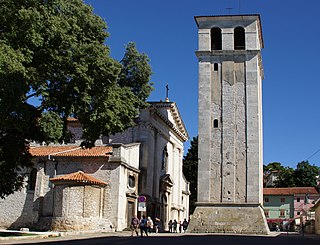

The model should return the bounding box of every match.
[29,145,112,157]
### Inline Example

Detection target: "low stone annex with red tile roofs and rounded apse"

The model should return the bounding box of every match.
[0,143,140,231]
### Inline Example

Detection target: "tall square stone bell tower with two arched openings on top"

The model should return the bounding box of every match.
[188,15,269,234]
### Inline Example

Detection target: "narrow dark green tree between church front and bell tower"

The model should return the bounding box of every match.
[183,136,198,213]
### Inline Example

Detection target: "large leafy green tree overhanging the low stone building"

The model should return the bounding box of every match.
[0,0,151,198]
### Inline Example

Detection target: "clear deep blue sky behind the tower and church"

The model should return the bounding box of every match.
[85,0,320,167]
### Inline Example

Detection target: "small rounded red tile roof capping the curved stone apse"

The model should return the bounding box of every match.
[50,171,107,186]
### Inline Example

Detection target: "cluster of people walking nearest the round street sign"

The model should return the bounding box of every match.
[131,215,160,237]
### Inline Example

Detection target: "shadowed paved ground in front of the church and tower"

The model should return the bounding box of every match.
[0,234,320,245]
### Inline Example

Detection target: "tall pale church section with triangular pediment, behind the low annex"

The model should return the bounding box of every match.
[69,100,190,229]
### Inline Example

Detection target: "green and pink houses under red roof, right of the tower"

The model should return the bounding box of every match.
[263,187,320,230]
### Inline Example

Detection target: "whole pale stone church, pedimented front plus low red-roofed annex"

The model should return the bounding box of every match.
[0,102,189,231]
